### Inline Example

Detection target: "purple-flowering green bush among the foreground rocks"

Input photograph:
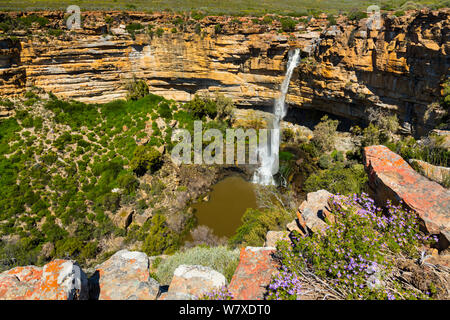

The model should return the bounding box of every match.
[268,193,432,299]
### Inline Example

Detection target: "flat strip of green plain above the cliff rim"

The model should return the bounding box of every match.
[0,0,442,16]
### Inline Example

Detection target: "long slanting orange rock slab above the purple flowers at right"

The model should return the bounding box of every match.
[364,145,450,249]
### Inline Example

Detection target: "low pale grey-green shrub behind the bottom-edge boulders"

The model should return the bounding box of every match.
[156,247,239,284]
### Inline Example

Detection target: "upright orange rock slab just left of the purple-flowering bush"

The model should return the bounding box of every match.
[228,247,277,300]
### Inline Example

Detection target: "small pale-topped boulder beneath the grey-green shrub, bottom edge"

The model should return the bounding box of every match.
[167,264,227,300]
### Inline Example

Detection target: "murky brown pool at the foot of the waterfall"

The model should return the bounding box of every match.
[192,176,257,237]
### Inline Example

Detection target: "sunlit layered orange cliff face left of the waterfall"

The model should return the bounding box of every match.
[0,12,316,104]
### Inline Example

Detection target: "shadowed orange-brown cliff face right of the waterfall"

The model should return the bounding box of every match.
[288,10,450,135]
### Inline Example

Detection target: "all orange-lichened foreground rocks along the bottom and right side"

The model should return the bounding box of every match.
[0,146,450,300]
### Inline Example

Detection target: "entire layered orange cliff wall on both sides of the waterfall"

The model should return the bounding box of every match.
[0,9,450,134]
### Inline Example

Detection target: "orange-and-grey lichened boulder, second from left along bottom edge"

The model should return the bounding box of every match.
[90,250,159,300]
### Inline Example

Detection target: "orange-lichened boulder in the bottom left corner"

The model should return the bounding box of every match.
[0,259,89,300]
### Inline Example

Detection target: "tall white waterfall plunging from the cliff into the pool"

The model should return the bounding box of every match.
[253,49,300,185]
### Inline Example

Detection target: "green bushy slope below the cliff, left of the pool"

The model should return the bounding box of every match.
[0,86,237,269]
